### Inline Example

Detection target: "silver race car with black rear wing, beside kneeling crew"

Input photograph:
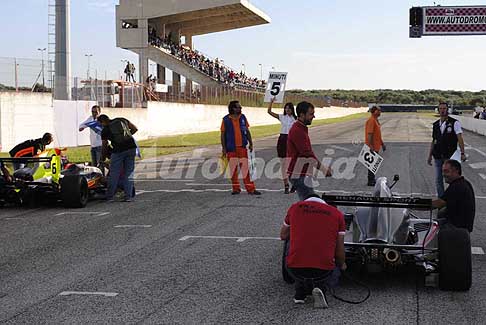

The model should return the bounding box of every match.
[282,175,472,291]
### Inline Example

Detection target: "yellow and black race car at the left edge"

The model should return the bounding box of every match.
[0,149,106,208]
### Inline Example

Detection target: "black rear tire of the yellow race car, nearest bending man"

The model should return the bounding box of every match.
[61,175,89,208]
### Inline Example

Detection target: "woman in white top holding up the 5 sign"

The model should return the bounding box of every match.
[268,97,297,194]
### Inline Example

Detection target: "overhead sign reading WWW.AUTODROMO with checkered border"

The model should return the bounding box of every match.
[410,6,486,37]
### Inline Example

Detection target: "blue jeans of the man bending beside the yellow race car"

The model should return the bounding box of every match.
[106,149,136,200]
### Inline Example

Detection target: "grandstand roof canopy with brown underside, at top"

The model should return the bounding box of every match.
[119,0,271,35]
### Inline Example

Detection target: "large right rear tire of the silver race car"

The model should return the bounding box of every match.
[439,226,472,291]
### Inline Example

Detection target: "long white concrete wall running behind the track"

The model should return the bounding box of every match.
[0,92,366,152]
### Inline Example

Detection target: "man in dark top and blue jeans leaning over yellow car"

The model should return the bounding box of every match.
[98,115,138,202]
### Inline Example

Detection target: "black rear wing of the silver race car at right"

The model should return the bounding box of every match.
[322,194,433,210]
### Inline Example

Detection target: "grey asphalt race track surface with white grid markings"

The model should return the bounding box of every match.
[0,114,486,324]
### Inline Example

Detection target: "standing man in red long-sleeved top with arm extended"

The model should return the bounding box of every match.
[287,102,332,200]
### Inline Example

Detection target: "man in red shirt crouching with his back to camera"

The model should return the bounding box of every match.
[280,194,346,308]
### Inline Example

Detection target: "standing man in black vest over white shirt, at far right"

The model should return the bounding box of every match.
[427,103,466,197]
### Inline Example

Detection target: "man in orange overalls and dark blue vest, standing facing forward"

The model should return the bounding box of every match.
[221,100,261,195]
